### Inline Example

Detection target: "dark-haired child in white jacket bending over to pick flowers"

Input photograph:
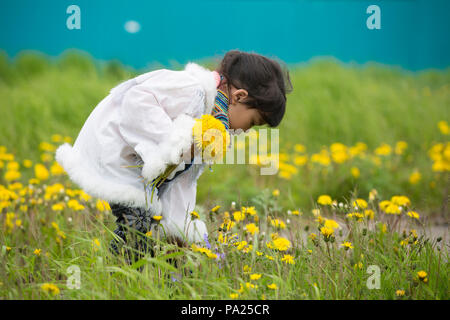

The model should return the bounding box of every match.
[56,50,292,258]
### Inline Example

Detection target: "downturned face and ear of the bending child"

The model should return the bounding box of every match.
[220,81,265,131]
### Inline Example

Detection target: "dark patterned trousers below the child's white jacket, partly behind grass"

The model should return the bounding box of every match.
[110,203,158,263]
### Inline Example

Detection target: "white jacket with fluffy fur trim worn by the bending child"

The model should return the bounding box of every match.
[56,62,217,242]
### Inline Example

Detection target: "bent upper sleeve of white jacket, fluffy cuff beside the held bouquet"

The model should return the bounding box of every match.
[119,82,195,181]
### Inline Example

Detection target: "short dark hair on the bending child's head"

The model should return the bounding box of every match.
[216,50,293,127]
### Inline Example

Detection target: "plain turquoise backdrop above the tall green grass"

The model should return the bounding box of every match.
[0,0,450,70]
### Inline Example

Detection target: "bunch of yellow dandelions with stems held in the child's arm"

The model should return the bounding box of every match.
[143,114,230,202]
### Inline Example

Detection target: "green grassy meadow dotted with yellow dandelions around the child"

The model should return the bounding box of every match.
[0,51,450,299]
